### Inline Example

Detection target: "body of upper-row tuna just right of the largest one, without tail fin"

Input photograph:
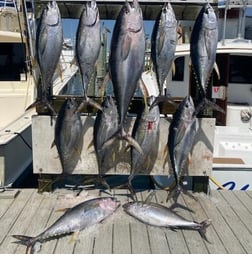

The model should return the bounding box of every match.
[151,3,177,94]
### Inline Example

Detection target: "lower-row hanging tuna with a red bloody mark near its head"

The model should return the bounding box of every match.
[128,96,160,196]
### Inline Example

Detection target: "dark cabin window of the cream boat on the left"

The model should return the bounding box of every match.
[0,43,26,81]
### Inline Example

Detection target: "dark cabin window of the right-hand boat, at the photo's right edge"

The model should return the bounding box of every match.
[229,56,252,84]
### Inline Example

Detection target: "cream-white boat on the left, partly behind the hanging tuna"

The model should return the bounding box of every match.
[0,0,77,186]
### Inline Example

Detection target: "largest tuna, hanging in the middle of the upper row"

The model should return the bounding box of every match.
[109,0,145,150]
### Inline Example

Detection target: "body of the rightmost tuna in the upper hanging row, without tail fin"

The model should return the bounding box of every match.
[190,3,218,99]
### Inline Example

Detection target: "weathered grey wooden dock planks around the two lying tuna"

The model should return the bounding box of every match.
[0,189,252,254]
